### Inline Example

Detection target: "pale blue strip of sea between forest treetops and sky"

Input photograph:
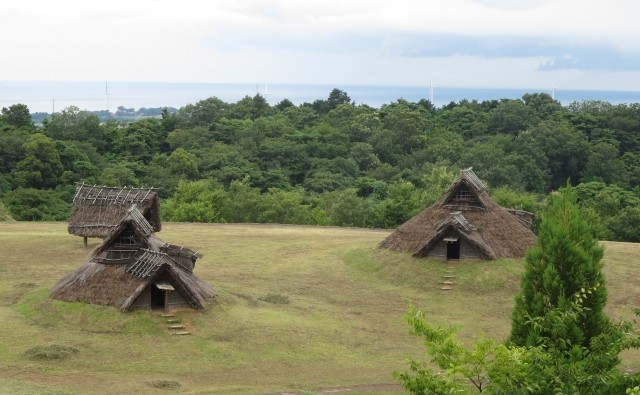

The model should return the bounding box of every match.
[0,81,640,114]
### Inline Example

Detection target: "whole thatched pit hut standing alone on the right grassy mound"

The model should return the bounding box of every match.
[380,168,536,259]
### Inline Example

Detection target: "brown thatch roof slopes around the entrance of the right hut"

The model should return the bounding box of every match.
[380,178,536,259]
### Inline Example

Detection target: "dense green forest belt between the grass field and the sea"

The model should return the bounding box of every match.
[0,89,640,242]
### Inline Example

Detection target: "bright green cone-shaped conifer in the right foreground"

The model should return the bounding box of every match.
[510,185,610,349]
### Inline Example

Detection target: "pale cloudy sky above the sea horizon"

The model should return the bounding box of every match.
[0,0,640,91]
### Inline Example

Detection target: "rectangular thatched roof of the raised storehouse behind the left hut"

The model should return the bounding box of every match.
[68,184,162,238]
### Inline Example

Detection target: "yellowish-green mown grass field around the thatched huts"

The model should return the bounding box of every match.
[0,222,640,394]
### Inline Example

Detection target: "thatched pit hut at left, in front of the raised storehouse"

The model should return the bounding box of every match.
[50,205,214,310]
